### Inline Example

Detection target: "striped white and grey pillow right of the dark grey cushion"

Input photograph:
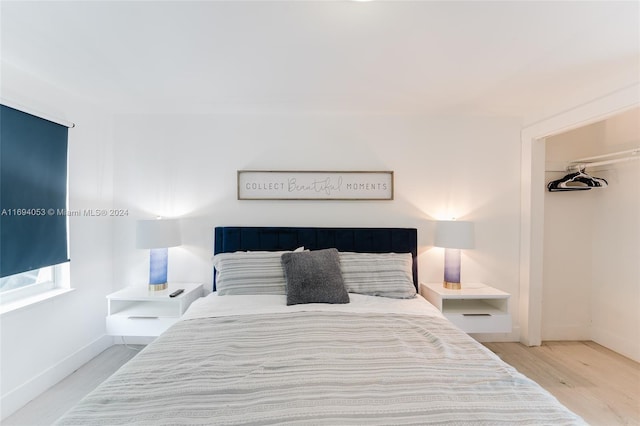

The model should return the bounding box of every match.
[340,252,416,299]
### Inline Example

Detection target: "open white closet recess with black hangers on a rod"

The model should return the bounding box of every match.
[542,108,640,361]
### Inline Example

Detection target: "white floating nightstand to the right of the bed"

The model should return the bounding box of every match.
[420,283,511,333]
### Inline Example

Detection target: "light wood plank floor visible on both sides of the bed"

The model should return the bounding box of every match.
[2,342,640,426]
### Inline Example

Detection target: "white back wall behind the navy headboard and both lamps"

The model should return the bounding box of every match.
[114,114,520,339]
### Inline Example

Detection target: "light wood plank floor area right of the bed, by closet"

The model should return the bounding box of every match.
[484,341,640,426]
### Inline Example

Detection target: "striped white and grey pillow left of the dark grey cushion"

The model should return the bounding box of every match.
[213,247,304,296]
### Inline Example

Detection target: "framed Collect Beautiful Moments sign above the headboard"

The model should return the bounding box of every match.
[238,170,393,200]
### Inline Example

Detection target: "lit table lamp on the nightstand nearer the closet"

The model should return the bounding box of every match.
[434,220,474,290]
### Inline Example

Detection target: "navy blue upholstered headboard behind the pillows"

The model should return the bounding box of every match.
[213,226,418,290]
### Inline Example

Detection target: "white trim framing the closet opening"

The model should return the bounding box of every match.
[518,83,640,346]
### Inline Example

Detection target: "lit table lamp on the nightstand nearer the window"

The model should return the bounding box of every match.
[136,218,181,291]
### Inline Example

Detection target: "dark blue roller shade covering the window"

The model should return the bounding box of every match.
[0,105,69,277]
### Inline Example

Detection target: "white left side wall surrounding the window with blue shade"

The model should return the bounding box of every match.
[0,63,113,418]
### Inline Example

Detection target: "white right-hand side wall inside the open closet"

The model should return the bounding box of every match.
[591,109,640,362]
